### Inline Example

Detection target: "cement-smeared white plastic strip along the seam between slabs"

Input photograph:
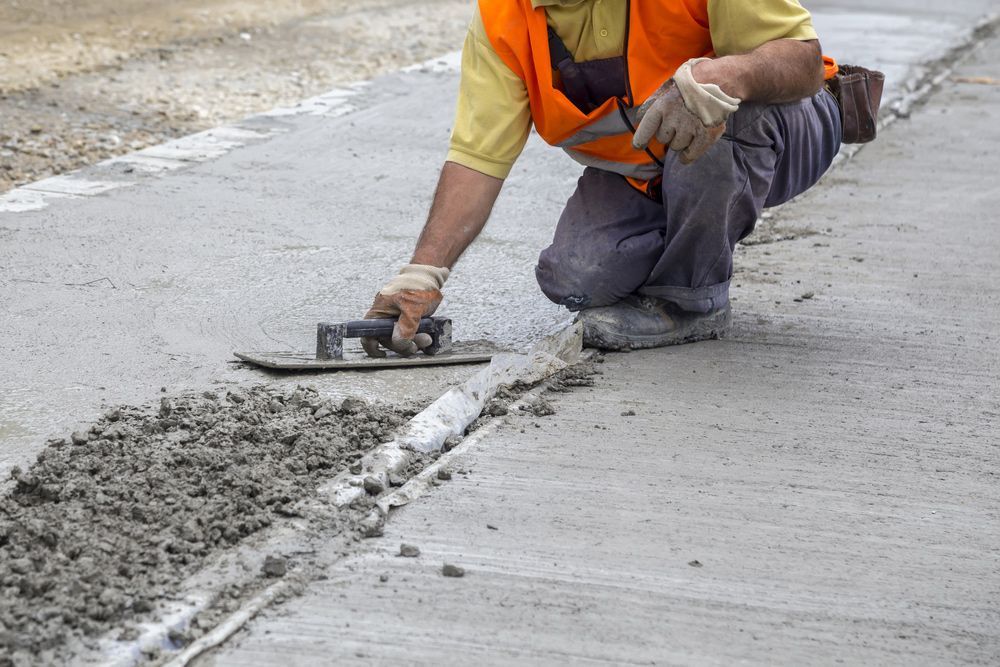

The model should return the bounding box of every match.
[146,323,584,666]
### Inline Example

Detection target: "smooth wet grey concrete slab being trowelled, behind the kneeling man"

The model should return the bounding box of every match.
[0,0,994,478]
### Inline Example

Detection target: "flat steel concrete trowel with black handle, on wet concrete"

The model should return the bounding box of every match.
[235,317,493,371]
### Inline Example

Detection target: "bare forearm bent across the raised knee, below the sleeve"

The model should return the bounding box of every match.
[692,39,823,104]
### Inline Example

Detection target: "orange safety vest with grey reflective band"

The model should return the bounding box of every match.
[479,0,836,186]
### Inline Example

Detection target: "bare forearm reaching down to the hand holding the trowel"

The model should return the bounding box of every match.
[410,162,503,269]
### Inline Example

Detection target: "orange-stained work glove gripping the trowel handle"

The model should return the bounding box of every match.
[361,264,450,358]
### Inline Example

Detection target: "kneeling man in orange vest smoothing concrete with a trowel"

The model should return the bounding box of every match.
[363,0,842,356]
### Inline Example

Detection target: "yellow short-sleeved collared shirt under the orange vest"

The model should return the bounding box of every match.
[447,0,817,178]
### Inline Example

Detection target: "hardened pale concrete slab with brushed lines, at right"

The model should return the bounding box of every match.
[201,18,1000,665]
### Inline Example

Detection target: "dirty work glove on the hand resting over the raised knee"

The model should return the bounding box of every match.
[632,58,742,164]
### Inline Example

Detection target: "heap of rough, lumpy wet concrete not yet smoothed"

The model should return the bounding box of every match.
[0,387,408,664]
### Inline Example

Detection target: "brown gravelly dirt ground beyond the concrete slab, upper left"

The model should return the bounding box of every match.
[0,0,471,192]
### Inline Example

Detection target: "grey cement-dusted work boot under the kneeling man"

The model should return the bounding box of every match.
[577,295,731,350]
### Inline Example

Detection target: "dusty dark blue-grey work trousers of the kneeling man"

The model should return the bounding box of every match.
[535,91,841,312]
